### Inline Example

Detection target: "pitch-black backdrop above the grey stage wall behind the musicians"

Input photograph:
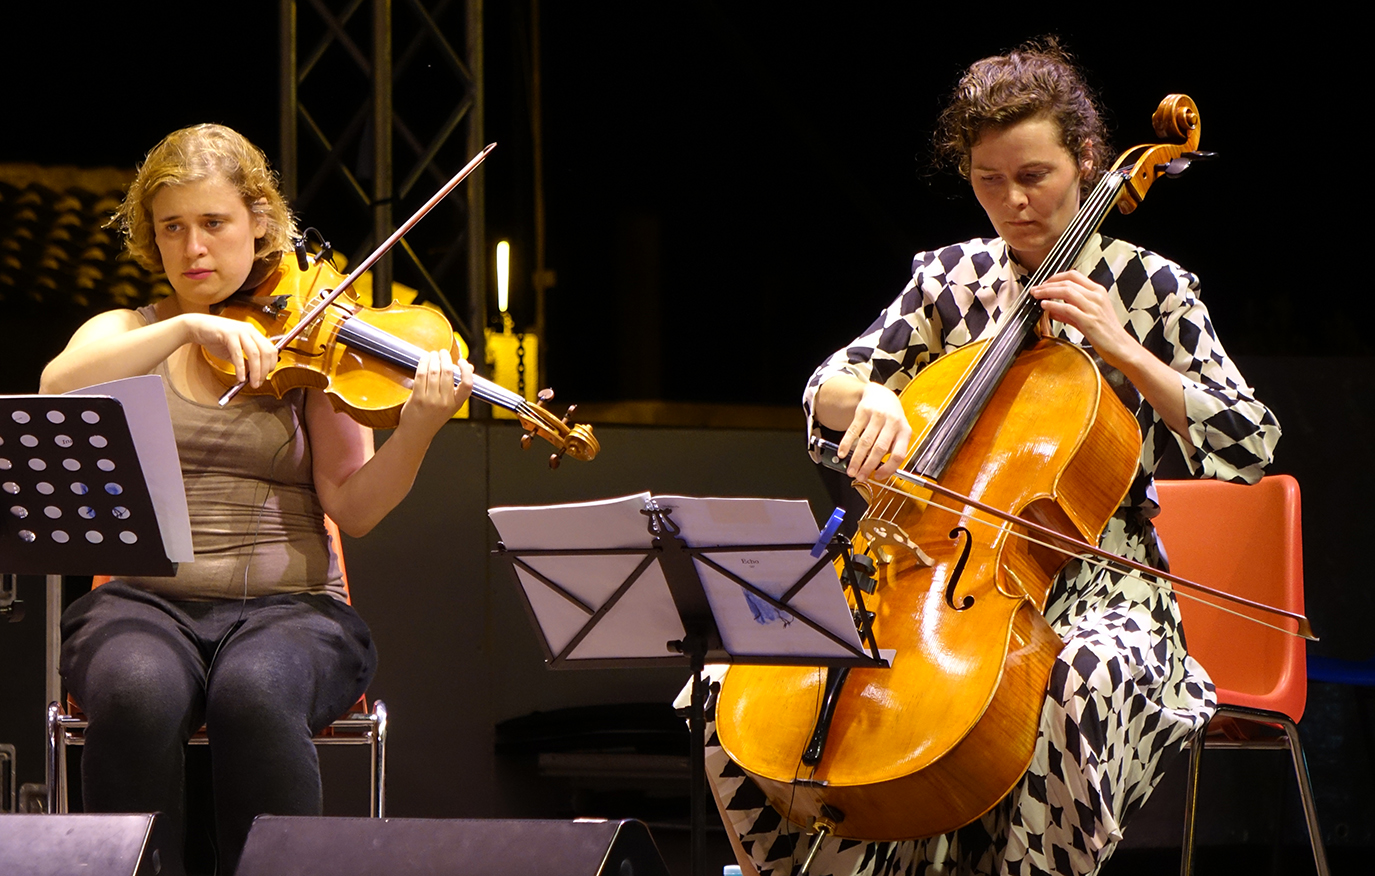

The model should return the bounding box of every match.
[0,0,1372,404]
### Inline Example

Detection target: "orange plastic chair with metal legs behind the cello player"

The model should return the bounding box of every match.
[1154,474,1328,876]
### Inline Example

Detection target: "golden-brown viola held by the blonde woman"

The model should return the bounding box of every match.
[202,248,600,468]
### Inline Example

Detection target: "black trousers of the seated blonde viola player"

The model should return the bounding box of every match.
[62,580,377,875]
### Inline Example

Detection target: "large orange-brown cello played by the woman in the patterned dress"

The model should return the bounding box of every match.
[716,95,1259,840]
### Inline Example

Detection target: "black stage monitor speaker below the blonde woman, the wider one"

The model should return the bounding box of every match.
[235,815,668,876]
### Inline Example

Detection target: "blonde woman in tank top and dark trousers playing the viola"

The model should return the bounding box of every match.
[41,125,473,873]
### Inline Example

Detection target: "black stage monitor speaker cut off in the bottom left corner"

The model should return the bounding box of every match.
[0,814,182,876]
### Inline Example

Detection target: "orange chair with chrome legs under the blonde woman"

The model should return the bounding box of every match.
[47,517,386,818]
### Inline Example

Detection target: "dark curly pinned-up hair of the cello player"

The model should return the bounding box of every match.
[935,37,1110,197]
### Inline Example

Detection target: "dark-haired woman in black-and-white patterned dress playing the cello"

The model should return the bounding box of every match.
[708,41,1279,876]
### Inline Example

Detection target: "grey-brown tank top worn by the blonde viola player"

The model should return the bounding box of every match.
[114,305,348,602]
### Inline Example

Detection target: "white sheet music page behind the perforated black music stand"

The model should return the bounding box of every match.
[66,374,195,562]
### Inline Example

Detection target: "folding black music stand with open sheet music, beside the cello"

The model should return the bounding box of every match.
[488,494,887,876]
